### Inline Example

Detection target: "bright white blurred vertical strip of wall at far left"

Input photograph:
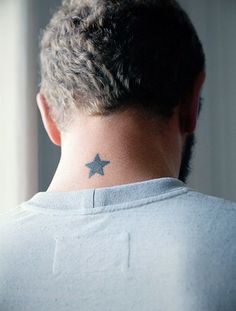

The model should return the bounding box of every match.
[0,0,38,212]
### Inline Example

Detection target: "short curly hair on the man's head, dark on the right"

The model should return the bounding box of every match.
[41,0,205,129]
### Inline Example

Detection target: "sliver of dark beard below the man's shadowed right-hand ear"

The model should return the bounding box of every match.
[178,134,195,183]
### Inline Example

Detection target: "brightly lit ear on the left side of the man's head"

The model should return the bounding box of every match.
[36,93,61,146]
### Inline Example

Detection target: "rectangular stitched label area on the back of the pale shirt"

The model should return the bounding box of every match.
[53,232,130,275]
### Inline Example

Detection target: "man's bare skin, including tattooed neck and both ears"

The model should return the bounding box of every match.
[37,72,205,192]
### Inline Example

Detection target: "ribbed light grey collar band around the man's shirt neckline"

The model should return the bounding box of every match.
[21,177,187,214]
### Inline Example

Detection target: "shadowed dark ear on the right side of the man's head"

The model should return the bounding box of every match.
[179,71,205,134]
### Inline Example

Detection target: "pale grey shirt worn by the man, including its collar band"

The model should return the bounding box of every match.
[0,178,236,311]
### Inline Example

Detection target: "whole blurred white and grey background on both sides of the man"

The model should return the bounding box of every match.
[0,0,236,212]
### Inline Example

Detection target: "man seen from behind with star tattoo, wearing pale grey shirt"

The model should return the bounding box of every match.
[0,0,236,311]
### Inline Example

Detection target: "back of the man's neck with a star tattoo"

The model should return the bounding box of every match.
[48,112,182,191]
